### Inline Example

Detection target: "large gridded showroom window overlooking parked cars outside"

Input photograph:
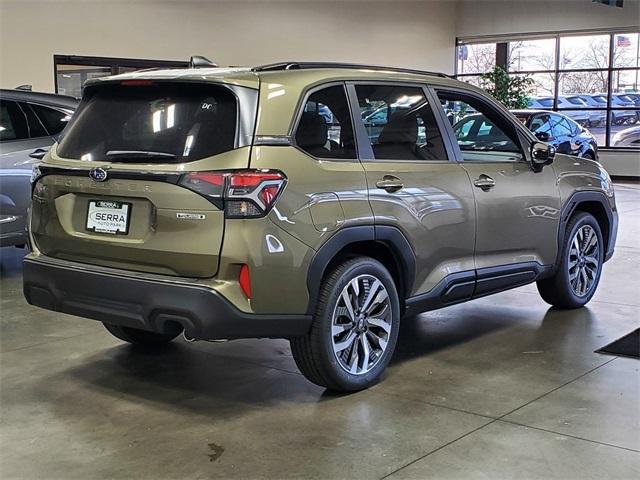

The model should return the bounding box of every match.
[457,31,640,148]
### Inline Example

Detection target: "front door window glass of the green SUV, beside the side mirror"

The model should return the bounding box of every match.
[438,92,524,162]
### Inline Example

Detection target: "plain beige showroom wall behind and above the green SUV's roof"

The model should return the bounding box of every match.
[0,0,455,91]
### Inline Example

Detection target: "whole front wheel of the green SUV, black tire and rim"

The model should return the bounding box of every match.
[538,212,604,309]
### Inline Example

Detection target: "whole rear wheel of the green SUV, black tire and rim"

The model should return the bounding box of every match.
[290,257,400,392]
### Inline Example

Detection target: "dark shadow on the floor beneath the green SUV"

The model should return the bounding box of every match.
[33,308,591,417]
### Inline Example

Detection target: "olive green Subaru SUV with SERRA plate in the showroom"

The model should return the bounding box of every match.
[24,63,618,391]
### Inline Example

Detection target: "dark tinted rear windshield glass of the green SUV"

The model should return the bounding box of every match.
[58,83,237,163]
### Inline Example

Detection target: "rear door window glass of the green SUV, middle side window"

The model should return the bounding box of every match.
[356,85,447,160]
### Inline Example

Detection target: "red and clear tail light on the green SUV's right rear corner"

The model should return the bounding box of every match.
[179,170,287,218]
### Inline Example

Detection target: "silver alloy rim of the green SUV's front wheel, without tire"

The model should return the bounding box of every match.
[568,225,600,297]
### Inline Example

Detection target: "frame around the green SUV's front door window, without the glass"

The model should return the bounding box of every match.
[433,86,537,166]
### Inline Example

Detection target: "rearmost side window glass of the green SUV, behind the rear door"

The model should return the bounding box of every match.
[295,85,356,159]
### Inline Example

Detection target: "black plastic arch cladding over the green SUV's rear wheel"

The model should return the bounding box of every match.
[307,225,416,313]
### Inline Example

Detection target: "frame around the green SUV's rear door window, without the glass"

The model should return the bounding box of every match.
[346,79,456,164]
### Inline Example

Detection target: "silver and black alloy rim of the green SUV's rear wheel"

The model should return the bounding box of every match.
[331,275,393,375]
